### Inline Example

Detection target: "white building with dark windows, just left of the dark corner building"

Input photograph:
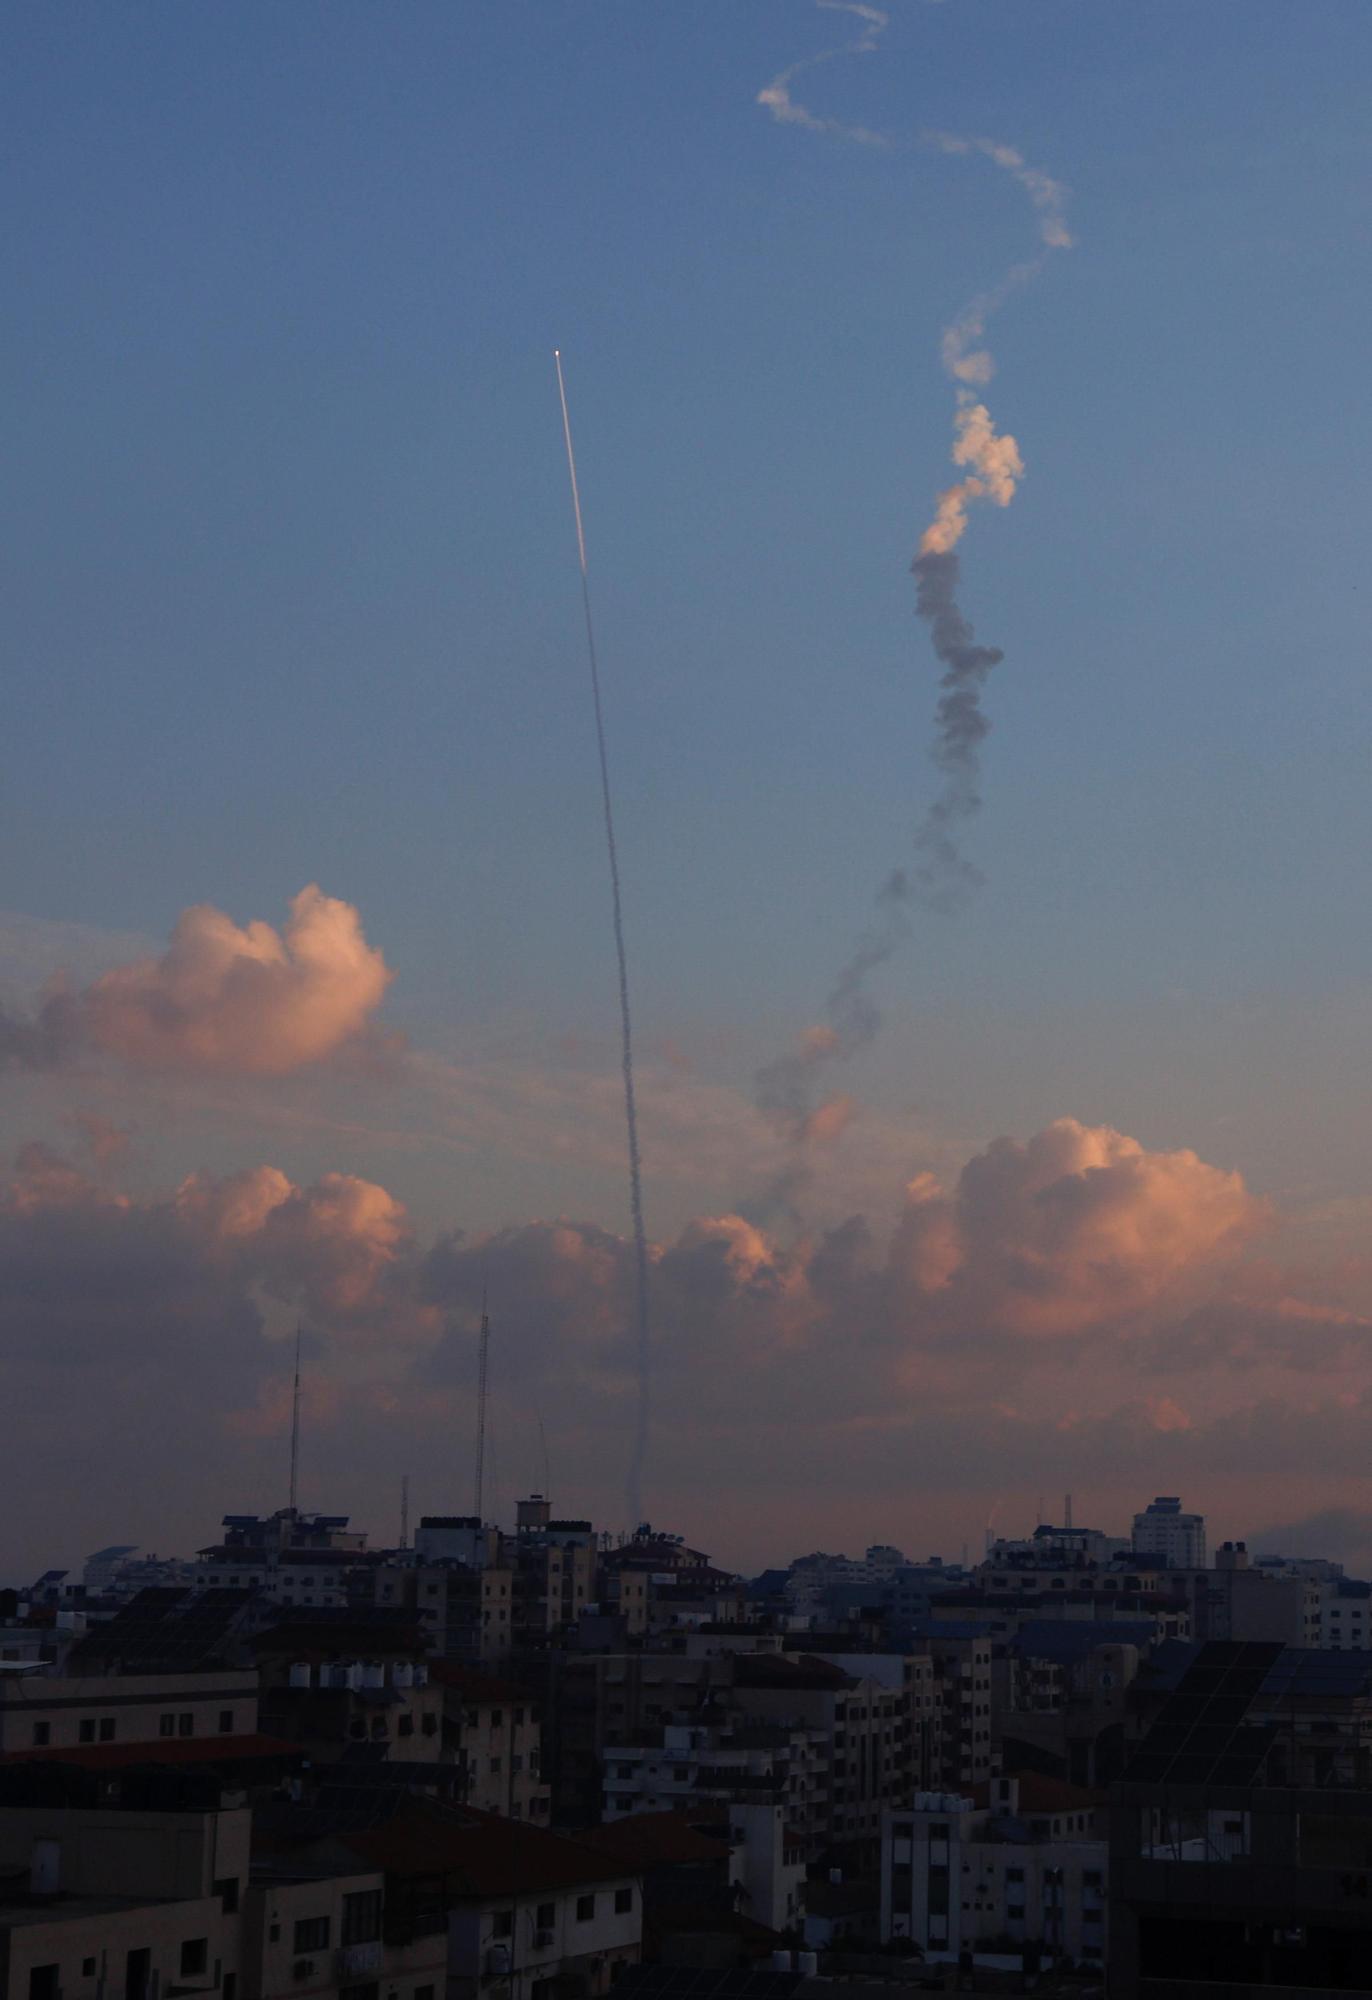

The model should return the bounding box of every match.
[882,1774,1110,1964]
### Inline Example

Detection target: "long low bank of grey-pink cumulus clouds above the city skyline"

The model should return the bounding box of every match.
[10,1120,1370,1568]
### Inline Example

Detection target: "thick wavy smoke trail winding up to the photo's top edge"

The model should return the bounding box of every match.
[752,0,1072,1210]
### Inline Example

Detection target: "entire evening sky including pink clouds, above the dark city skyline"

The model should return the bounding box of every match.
[0,0,1372,1580]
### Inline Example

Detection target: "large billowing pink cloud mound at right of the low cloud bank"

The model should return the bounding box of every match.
[894,1118,1266,1338]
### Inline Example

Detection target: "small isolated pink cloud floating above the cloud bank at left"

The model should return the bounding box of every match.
[0,884,392,1076]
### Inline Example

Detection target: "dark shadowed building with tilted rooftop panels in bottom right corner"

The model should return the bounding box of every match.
[1110,1642,1372,2000]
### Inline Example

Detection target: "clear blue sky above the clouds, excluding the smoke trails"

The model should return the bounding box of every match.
[0,0,1372,1576]
